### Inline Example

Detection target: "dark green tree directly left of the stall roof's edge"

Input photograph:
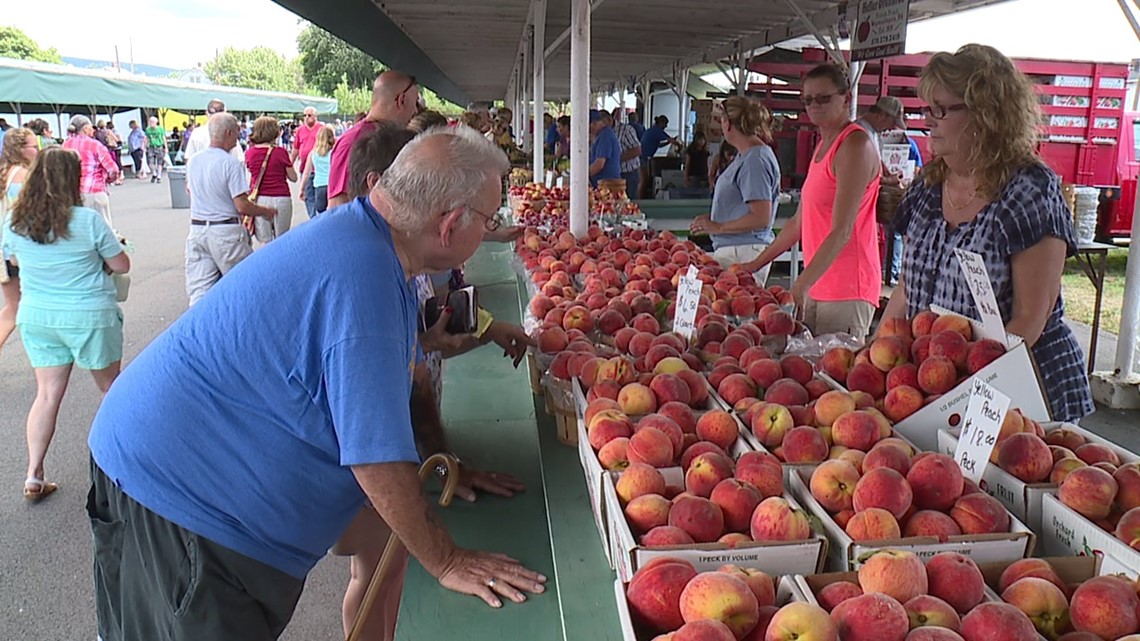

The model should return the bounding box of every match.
[296,24,384,96]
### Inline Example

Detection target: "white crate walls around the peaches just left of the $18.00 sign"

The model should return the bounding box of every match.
[789,463,1036,571]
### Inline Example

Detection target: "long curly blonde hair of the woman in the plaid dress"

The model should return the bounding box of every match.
[919,44,1041,198]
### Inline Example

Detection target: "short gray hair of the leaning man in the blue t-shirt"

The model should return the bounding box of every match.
[378,127,511,232]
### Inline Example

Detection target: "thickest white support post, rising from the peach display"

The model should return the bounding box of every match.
[570,0,589,238]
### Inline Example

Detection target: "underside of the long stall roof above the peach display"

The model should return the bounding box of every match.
[275,0,1005,104]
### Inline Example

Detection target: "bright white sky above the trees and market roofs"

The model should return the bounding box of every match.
[0,0,1140,68]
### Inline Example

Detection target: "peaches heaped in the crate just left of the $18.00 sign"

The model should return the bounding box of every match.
[808,439,1010,541]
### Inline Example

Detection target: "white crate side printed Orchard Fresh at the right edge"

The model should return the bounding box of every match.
[1041,494,1140,581]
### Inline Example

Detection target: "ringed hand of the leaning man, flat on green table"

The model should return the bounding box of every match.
[439,547,546,608]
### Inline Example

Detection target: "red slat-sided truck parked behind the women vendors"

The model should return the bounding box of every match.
[748,49,1140,240]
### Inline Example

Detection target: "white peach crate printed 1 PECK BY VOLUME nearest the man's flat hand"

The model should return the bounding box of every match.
[602,468,828,582]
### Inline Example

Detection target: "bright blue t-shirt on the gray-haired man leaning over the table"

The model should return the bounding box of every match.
[88,198,418,578]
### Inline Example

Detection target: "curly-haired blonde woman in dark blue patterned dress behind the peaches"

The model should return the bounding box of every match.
[884,44,1094,421]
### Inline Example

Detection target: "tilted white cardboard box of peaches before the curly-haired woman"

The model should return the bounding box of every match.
[857,308,1051,452]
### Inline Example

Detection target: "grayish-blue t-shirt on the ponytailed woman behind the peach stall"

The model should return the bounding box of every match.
[709,145,780,249]
